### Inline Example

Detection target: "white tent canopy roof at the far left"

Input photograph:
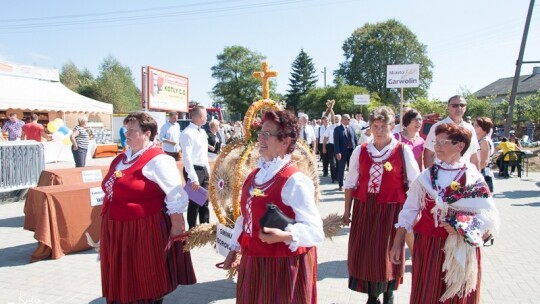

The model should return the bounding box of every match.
[0,74,113,114]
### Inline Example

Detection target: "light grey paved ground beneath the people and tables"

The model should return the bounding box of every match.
[0,159,540,304]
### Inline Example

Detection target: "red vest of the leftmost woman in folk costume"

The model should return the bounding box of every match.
[101,147,165,221]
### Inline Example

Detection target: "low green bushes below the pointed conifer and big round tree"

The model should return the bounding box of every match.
[298,84,382,118]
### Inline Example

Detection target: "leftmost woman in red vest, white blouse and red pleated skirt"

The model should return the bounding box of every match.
[100,112,196,303]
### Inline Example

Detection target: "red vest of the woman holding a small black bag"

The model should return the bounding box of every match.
[240,166,307,257]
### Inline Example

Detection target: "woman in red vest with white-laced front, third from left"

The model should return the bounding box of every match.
[343,106,419,303]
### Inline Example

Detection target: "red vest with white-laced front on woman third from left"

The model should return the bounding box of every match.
[353,143,407,204]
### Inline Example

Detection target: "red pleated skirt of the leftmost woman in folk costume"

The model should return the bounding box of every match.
[100,210,197,303]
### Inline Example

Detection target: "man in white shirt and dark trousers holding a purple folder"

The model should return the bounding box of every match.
[180,106,210,229]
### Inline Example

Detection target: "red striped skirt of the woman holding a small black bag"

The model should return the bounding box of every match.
[236,247,317,304]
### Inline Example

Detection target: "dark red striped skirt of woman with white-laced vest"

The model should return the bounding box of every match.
[347,193,405,295]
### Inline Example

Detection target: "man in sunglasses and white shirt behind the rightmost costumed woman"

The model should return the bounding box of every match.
[424,95,480,170]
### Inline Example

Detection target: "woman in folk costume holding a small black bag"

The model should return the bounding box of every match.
[223,111,324,304]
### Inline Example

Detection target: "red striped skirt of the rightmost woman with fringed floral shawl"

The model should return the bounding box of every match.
[410,233,482,304]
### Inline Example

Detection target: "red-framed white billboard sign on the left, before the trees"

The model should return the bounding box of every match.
[142,67,189,113]
